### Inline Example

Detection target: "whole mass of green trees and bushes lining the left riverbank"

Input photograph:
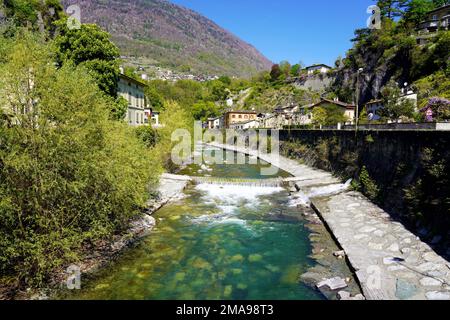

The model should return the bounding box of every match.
[0,2,192,294]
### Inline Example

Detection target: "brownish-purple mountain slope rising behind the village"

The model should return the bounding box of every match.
[61,0,271,76]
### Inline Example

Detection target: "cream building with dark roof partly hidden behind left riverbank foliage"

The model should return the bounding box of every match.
[117,73,146,126]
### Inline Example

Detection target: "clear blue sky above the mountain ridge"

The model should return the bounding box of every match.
[170,0,375,65]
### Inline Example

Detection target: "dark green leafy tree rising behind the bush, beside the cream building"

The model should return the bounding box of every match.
[55,20,120,97]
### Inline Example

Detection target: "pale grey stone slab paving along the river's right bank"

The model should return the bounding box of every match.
[210,143,450,300]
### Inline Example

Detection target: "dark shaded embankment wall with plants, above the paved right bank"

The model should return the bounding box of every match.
[280,130,450,247]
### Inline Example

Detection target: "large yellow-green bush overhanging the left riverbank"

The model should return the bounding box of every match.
[0,36,159,285]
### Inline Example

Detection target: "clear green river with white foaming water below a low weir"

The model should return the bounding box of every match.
[64,150,323,300]
